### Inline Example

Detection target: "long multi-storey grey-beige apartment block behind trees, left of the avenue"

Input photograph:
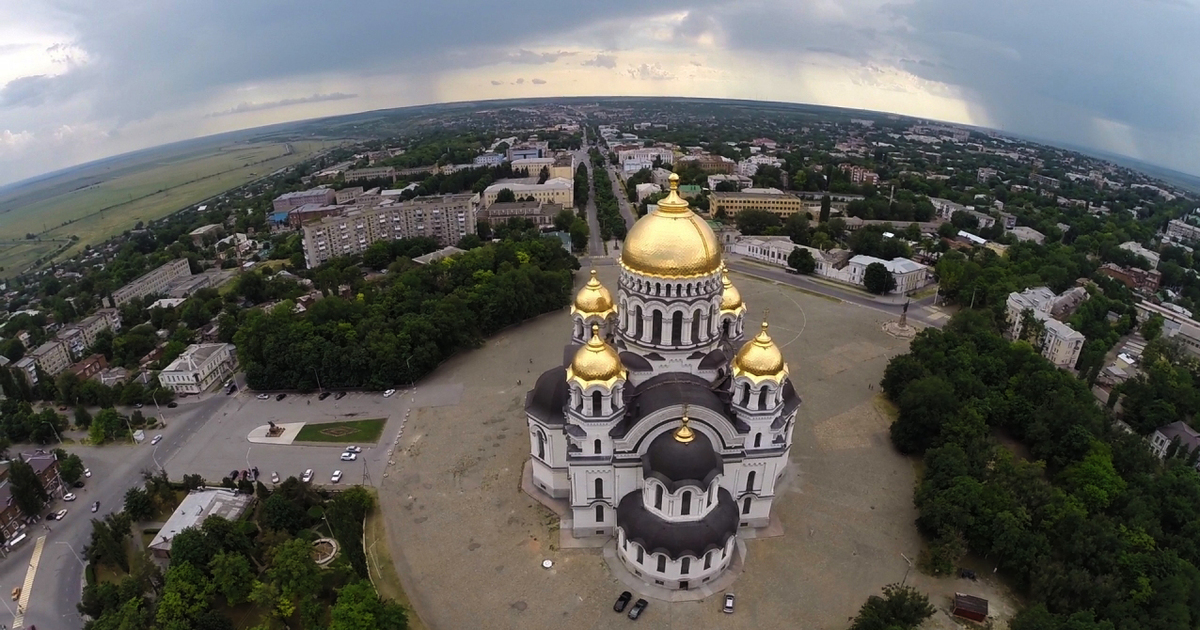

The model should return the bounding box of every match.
[304,193,475,269]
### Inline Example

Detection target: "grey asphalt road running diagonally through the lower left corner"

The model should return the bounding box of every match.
[0,396,226,629]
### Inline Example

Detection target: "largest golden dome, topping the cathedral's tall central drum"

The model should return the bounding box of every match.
[620,173,721,278]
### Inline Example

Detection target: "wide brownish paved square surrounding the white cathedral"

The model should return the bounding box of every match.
[380,266,1012,629]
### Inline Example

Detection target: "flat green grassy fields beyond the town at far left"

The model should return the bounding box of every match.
[0,142,336,276]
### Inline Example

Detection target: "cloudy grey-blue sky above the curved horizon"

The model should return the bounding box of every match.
[0,0,1200,184]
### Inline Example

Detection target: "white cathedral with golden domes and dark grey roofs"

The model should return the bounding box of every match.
[526,175,800,589]
